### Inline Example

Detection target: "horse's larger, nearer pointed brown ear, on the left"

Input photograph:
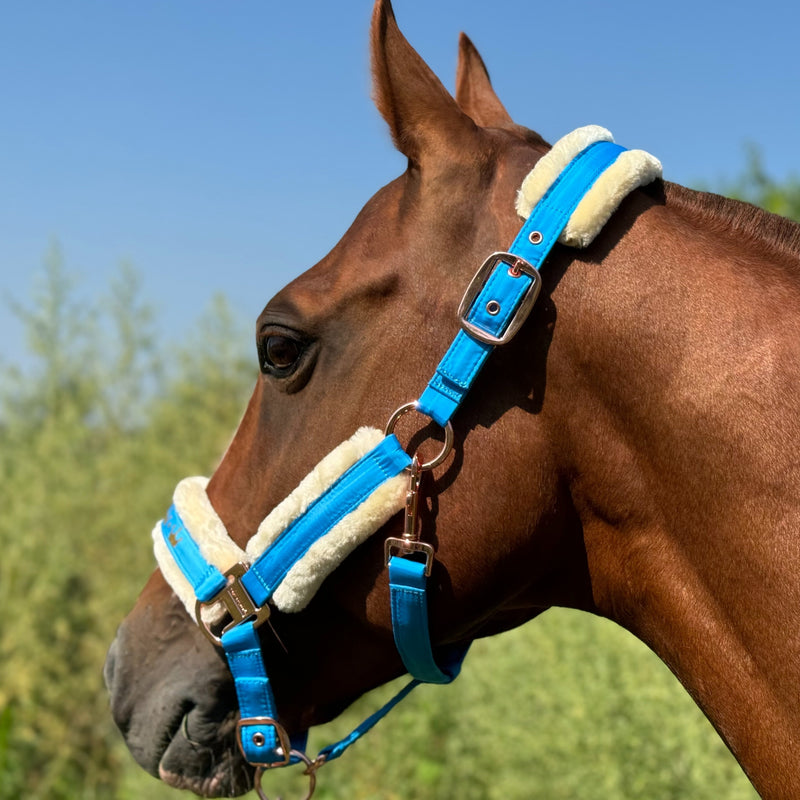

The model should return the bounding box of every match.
[371,0,477,164]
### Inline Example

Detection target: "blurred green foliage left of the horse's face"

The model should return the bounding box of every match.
[0,248,254,800]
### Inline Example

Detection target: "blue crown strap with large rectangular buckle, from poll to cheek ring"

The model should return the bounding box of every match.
[418,142,625,425]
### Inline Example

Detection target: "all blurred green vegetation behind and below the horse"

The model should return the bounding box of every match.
[0,158,800,800]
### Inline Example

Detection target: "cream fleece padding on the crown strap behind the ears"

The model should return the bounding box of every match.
[516,125,662,247]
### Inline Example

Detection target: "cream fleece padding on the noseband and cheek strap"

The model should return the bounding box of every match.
[153,428,407,621]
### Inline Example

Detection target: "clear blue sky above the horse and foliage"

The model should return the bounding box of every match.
[0,0,800,362]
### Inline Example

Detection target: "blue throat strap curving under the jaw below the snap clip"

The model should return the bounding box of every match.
[389,556,467,683]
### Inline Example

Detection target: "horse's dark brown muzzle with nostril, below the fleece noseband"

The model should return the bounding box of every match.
[104,576,253,797]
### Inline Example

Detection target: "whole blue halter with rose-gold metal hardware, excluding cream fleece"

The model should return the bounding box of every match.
[162,141,625,797]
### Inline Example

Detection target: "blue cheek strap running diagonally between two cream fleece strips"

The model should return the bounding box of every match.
[242,435,411,606]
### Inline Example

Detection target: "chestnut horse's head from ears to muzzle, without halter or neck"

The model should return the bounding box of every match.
[107,3,574,794]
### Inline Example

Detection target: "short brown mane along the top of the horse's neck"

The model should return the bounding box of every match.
[664,181,800,259]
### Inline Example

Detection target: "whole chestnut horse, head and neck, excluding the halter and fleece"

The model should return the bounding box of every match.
[105,0,800,798]
